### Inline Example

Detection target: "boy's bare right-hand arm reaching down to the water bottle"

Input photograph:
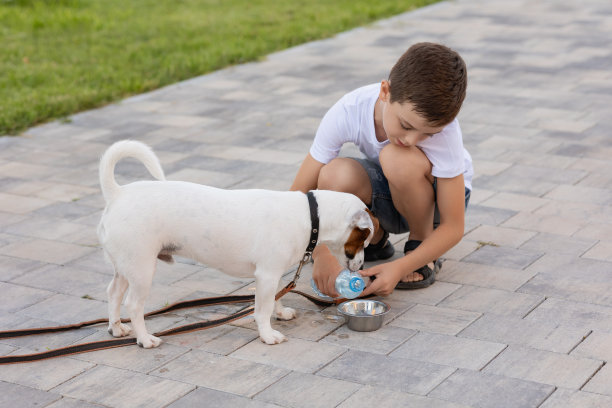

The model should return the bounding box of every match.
[362,175,465,296]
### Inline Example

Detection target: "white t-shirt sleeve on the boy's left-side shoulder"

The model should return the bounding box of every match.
[310,98,354,164]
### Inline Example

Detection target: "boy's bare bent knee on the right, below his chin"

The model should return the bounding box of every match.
[379,145,433,184]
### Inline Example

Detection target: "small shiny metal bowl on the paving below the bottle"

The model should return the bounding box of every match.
[338,299,390,331]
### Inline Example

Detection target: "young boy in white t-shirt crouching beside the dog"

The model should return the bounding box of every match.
[291,43,473,297]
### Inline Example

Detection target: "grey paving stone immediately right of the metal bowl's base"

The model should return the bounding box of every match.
[390,305,480,335]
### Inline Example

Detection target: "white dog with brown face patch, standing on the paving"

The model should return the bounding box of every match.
[98,141,374,348]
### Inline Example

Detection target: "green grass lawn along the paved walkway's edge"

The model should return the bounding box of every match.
[0,0,436,135]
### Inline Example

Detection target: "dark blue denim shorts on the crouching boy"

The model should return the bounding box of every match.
[352,157,471,234]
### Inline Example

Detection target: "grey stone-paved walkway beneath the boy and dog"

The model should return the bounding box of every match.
[0,0,612,408]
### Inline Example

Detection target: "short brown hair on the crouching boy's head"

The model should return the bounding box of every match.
[389,42,467,126]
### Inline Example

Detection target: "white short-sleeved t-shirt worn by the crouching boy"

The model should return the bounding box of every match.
[310,83,474,190]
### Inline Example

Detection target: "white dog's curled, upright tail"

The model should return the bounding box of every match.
[100,140,166,202]
